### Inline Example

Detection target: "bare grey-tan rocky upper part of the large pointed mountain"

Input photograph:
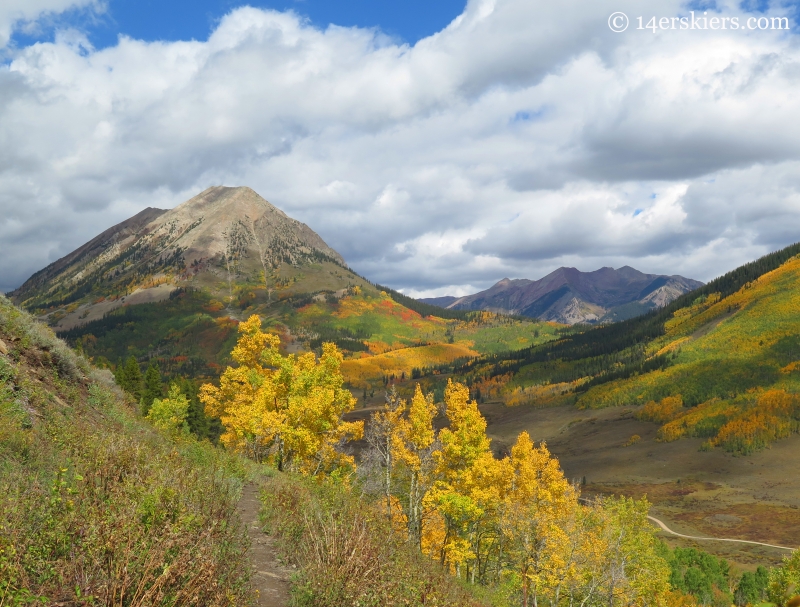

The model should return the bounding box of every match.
[10,186,345,329]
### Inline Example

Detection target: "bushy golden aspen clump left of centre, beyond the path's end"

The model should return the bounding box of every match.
[200,315,363,474]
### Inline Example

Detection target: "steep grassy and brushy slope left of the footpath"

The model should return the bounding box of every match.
[0,296,249,606]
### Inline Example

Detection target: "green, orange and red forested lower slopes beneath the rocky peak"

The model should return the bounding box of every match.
[38,262,562,394]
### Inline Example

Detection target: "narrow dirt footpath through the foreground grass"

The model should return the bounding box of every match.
[239,484,291,607]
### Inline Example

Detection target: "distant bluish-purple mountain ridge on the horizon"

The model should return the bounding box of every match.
[421,266,703,325]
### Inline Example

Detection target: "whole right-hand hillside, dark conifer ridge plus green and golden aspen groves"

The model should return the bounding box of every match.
[438,245,800,453]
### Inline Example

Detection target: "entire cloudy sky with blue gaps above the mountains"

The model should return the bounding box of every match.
[0,0,800,296]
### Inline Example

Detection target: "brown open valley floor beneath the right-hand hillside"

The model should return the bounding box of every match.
[481,404,800,569]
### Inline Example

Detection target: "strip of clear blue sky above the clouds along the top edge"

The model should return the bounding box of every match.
[13,0,466,49]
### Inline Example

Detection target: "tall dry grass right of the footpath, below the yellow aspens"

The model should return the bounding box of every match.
[261,474,485,607]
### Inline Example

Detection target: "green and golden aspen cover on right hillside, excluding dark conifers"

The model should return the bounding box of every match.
[578,249,800,453]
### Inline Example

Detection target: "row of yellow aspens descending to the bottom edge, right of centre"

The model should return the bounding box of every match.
[368,381,668,607]
